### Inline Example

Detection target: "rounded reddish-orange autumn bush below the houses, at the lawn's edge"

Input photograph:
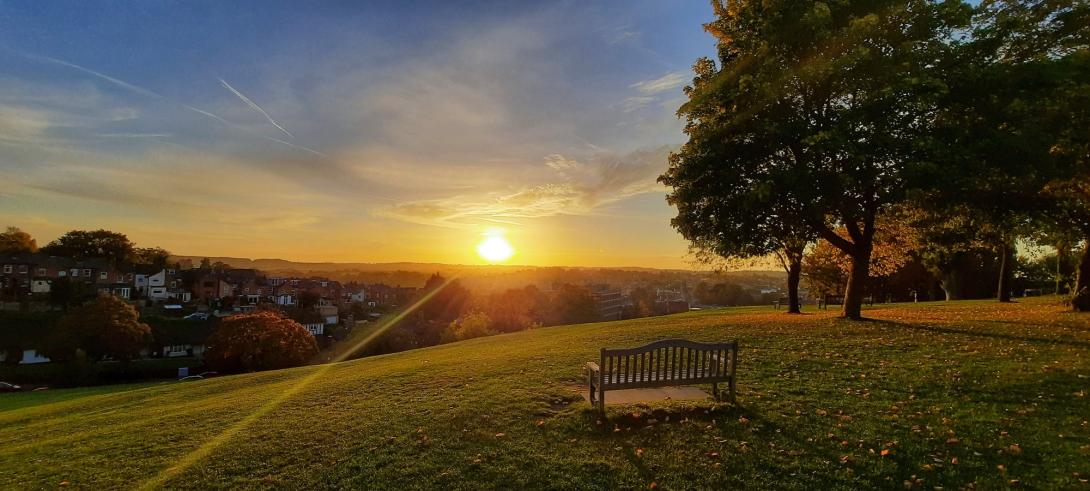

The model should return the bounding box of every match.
[204,311,318,372]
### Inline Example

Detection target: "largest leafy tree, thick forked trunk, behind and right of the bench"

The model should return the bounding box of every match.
[664,0,969,319]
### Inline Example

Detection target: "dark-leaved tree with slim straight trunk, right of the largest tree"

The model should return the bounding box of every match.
[919,0,1087,301]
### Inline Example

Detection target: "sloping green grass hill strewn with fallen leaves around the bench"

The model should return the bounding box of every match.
[0,299,1090,489]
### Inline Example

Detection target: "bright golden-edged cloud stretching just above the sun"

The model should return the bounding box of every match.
[379,147,671,227]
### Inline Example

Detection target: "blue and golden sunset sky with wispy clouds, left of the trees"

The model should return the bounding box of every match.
[0,0,714,267]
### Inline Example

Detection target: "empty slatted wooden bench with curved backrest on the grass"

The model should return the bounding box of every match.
[586,339,738,412]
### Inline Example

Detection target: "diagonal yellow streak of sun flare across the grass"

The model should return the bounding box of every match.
[136,274,459,490]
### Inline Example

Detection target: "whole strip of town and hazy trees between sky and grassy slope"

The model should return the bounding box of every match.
[0,249,780,373]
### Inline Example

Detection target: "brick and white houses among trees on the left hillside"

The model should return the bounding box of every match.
[0,254,425,363]
